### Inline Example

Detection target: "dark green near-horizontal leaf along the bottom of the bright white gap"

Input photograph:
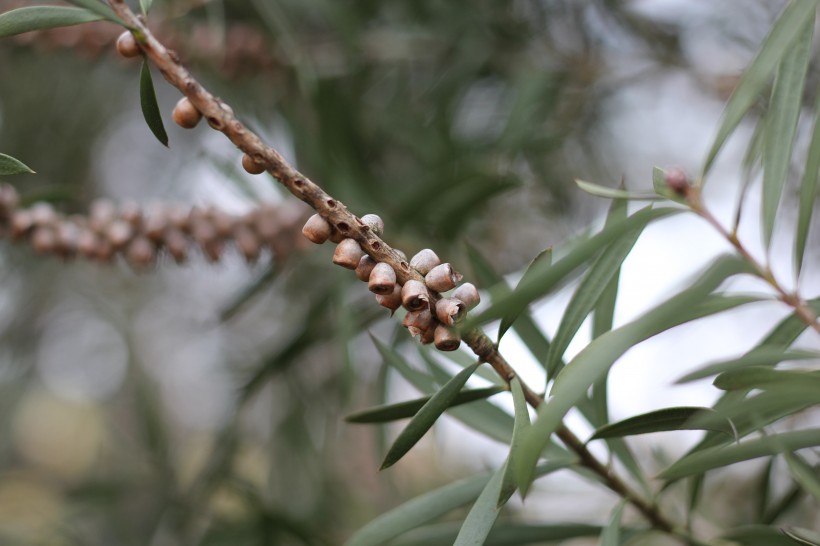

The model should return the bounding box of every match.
[587,407,733,442]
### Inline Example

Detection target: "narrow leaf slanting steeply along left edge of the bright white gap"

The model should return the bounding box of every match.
[546,219,641,377]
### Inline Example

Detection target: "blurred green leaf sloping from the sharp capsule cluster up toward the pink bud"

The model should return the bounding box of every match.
[464,207,681,329]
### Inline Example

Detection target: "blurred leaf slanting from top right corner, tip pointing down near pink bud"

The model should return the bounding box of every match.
[701,0,817,178]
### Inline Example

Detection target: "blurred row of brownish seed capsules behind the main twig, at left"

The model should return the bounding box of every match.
[0,184,304,268]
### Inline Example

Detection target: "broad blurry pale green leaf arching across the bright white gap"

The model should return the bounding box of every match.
[514,253,749,492]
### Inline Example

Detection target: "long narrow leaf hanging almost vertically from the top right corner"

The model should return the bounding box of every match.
[761,13,814,247]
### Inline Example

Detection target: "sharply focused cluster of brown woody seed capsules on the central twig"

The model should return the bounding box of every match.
[302,210,480,351]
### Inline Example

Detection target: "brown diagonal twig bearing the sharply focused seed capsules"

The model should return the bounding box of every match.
[105,0,697,544]
